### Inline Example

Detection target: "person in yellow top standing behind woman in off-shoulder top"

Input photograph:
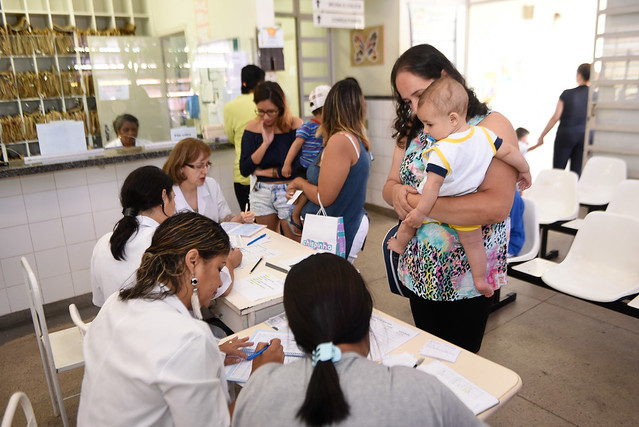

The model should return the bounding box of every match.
[224,65,265,209]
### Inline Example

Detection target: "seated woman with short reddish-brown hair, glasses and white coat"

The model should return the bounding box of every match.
[162,138,255,223]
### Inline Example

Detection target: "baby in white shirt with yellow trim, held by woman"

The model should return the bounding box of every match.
[388,77,531,297]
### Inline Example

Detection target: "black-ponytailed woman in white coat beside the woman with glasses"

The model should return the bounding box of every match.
[91,166,175,307]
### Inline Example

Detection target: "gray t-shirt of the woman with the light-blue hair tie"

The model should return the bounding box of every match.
[233,353,484,427]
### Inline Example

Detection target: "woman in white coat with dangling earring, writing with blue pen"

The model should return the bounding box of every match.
[78,212,284,426]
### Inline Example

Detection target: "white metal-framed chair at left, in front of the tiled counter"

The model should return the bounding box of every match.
[20,257,84,427]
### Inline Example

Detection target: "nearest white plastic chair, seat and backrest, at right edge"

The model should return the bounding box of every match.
[541,212,639,302]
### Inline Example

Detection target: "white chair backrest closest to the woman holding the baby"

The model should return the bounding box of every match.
[524,169,579,224]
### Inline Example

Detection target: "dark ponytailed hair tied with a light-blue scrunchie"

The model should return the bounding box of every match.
[284,253,373,426]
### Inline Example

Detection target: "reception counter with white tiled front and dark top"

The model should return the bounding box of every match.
[0,141,239,316]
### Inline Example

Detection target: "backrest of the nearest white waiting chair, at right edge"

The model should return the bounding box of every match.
[563,211,639,281]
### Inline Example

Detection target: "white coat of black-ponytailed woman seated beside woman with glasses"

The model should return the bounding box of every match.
[91,215,160,307]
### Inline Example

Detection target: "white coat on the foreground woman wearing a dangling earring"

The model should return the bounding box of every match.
[78,294,230,427]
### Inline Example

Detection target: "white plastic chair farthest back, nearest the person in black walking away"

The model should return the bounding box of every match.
[579,156,627,206]
